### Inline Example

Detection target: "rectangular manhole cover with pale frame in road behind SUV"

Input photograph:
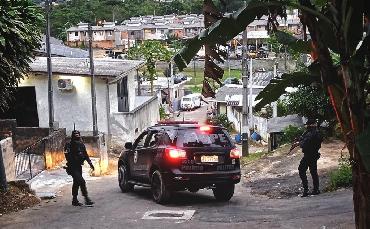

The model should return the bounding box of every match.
[142,210,195,220]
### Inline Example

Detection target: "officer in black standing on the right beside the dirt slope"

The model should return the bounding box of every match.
[291,119,323,197]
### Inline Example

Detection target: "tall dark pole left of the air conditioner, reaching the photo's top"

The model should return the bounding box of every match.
[45,0,54,132]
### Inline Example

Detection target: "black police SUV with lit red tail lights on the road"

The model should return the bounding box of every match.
[118,121,240,203]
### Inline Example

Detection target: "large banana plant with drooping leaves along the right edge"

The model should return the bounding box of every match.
[174,0,370,226]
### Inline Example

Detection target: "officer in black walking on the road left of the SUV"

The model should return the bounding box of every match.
[64,130,95,206]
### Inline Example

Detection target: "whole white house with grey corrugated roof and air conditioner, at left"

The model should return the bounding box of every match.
[17,57,159,146]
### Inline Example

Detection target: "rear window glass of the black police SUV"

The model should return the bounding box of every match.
[166,128,232,147]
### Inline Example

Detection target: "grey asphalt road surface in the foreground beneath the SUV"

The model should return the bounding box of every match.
[0,175,354,229]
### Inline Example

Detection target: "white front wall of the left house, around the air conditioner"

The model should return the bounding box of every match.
[19,74,107,133]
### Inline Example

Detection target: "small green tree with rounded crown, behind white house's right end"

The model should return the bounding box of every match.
[128,41,173,95]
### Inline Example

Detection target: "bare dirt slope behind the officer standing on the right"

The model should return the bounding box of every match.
[243,140,348,199]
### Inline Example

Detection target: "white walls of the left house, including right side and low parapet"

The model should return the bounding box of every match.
[19,71,159,147]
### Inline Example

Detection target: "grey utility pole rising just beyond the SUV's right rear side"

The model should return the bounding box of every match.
[241,5,249,156]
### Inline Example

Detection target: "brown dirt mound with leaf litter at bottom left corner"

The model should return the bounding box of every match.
[0,182,40,215]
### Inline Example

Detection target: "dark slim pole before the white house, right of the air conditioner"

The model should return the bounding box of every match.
[88,23,98,136]
